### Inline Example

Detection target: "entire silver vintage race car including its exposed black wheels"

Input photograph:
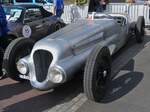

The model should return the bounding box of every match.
[3,13,145,100]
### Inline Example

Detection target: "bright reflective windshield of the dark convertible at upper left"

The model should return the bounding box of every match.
[8,8,22,22]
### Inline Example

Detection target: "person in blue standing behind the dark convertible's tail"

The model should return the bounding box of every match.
[54,0,64,18]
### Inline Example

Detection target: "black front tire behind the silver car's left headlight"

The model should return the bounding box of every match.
[2,38,34,82]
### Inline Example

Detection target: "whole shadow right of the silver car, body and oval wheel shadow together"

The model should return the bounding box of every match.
[98,36,150,104]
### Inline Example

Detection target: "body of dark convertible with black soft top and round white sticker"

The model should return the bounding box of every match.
[3,5,63,40]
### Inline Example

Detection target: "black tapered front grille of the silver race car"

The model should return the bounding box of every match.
[33,50,53,82]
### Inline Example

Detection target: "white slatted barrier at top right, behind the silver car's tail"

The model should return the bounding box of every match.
[107,3,150,25]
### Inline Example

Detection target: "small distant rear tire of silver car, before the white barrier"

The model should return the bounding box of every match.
[135,16,145,43]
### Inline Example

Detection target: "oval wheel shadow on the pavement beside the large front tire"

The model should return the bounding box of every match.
[102,72,144,103]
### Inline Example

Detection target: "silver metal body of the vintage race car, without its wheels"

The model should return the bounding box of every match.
[13,13,142,90]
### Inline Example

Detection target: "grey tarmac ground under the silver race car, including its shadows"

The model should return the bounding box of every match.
[0,30,150,112]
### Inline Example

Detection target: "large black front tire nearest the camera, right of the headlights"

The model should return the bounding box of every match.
[83,45,111,102]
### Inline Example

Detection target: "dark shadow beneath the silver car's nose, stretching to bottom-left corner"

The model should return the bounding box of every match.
[3,79,83,112]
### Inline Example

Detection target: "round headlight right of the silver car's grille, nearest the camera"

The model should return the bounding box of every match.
[49,67,66,83]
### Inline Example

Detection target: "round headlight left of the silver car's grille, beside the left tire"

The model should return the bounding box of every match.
[16,60,29,75]
